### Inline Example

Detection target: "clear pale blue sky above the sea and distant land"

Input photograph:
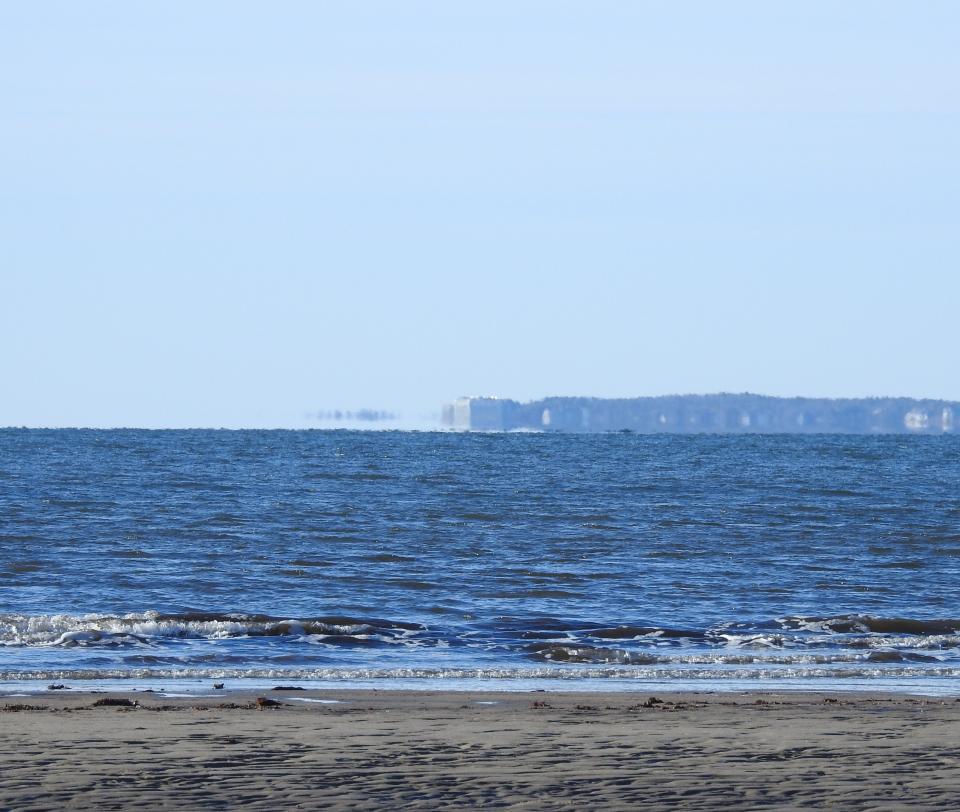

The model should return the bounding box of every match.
[0,0,960,428]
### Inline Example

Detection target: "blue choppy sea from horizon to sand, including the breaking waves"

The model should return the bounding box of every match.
[0,430,960,693]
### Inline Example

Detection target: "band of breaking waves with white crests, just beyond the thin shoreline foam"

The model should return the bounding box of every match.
[0,611,960,665]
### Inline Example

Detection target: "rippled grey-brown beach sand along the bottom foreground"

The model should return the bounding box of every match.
[0,691,960,812]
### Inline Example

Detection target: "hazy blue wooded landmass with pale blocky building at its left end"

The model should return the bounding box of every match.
[442,393,960,434]
